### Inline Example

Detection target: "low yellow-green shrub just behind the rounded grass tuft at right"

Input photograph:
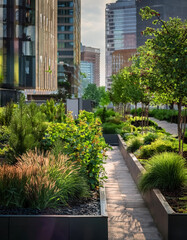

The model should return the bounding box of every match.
[136,139,176,159]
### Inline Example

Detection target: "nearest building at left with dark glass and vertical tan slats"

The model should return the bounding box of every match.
[0,0,57,104]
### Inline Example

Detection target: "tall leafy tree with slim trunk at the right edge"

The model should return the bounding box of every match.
[138,7,187,154]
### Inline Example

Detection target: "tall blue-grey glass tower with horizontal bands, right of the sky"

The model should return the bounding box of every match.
[105,0,136,89]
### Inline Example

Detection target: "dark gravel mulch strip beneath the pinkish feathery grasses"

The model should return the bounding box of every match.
[0,192,100,215]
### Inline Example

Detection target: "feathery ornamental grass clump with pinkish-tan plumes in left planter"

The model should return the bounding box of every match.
[0,151,89,209]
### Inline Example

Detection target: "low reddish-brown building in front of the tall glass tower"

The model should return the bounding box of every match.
[112,49,136,74]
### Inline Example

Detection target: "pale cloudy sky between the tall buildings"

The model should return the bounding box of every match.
[81,0,116,86]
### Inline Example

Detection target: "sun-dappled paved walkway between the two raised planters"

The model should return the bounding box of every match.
[106,147,161,240]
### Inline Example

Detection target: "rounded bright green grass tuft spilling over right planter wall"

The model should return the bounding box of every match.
[139,152,187,192]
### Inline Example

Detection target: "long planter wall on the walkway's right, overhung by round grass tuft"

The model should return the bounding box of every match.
[118,135,187,240]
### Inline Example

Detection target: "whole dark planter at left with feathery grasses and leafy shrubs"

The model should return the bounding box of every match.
[0,101,108,240]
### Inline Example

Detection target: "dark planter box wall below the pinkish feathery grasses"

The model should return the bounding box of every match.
[0,188,108,240]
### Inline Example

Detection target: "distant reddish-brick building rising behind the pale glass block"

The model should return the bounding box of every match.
[81,46,100,87]
